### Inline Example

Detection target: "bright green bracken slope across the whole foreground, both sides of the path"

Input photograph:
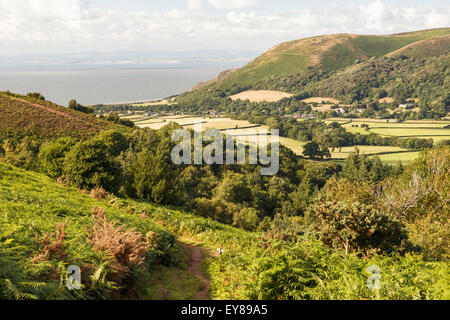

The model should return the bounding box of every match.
[0,145,449,300]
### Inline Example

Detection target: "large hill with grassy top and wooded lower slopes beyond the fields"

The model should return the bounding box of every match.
[177,28,450,105]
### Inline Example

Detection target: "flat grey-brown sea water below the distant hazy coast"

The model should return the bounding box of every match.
[0,66,226,106]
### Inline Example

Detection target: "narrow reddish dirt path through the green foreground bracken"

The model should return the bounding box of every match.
[178,241,215,300]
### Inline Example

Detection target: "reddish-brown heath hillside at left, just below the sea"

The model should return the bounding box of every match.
[0,92,114,140]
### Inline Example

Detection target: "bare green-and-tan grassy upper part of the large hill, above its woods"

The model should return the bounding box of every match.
[205,28,450,90]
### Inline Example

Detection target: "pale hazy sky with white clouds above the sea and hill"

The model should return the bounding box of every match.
[0,0,450,55]
